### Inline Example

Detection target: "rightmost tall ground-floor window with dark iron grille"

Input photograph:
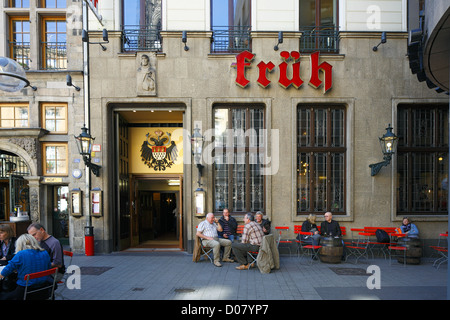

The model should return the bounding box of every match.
[397,105,448,215]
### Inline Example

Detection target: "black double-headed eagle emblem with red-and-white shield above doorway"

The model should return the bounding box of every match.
[141,130,178,171]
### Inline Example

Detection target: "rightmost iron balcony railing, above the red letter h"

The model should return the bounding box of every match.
[300,26,339,53]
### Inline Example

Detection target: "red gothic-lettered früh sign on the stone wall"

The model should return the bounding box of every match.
[233,51,333,92]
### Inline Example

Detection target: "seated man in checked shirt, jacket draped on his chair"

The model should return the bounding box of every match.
[232,213,264,270]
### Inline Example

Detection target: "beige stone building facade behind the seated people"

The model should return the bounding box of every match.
[0,0,448,252]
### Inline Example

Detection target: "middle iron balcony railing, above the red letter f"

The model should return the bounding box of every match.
[211,26,251,53]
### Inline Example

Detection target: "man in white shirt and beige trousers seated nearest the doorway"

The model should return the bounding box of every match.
[197,213,234,267]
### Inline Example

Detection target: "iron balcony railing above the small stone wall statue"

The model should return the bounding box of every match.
[122,25,162,52]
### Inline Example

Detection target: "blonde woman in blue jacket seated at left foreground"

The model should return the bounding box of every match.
[0,233,52,300]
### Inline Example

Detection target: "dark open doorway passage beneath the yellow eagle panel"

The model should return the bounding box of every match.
[138,190,179,248]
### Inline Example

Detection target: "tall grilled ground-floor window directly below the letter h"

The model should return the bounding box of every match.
[297,105,346,214]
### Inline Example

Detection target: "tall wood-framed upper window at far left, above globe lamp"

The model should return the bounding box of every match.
[9,17,31,70]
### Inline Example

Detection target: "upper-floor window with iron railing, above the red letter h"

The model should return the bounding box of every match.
[299,0,339,52]
